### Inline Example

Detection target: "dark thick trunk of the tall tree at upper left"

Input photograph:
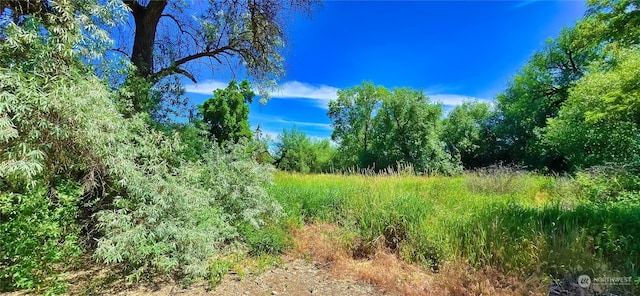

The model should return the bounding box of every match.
[124,0,167,79]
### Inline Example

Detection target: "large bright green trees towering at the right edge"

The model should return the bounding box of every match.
[495,0,640,172]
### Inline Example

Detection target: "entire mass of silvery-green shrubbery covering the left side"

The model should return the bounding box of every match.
[0,1,280,292]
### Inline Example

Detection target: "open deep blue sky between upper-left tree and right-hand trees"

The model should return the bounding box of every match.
[185,0,585,139]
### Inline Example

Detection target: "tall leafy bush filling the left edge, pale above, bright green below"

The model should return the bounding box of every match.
[0,10,125,292]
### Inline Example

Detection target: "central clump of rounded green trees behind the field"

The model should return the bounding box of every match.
[328,83,460,174]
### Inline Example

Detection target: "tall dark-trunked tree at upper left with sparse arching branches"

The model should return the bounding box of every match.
[118,0,314,111]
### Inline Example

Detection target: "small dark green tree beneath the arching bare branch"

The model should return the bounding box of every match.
[198,80,255,144]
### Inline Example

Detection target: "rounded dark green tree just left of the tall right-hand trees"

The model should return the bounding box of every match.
[442,101,493,169]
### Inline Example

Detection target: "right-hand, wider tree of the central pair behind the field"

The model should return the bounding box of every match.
[373,88,459,174]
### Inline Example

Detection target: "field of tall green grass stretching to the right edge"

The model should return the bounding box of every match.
[270,172,640,289]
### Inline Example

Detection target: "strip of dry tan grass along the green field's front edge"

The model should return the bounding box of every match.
[293,223,545,296]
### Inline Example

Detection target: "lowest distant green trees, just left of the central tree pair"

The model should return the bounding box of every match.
[274,126,334,173]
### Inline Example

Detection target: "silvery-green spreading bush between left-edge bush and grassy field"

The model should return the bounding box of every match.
[96,137,279,276]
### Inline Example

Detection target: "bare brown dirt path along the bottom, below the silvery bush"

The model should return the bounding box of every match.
[63,258,383,296]
